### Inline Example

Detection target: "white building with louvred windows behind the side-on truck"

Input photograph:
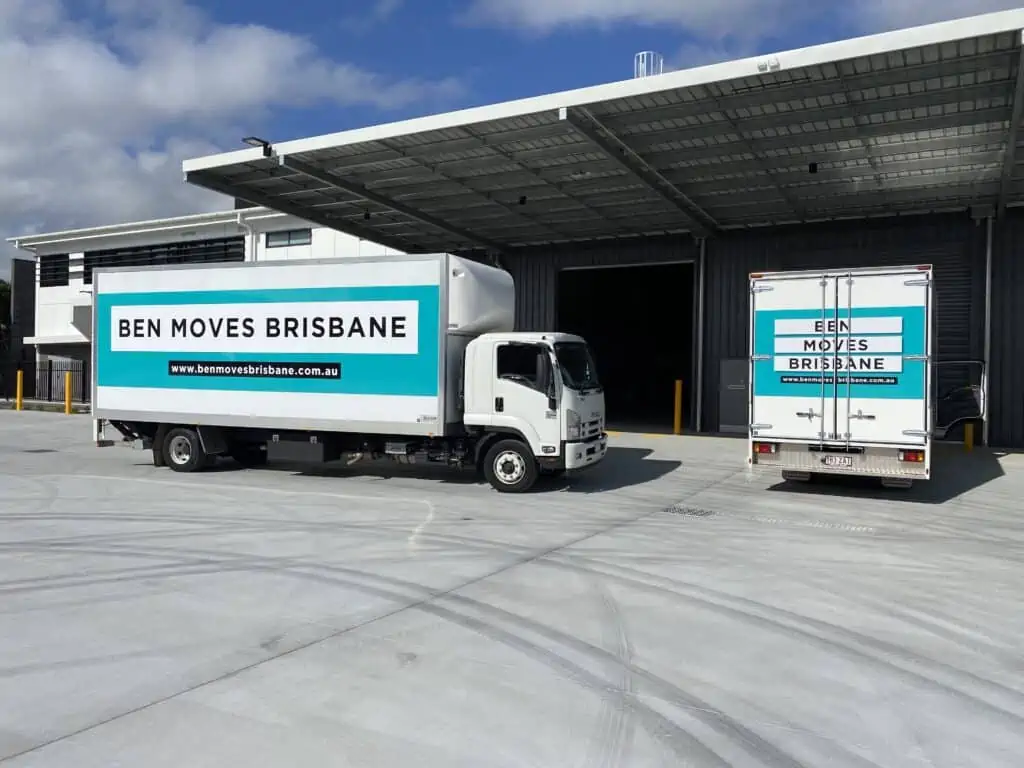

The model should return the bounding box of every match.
[8,202,407,374]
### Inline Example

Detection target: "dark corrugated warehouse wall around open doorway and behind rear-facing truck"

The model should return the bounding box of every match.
[489,214,991,439]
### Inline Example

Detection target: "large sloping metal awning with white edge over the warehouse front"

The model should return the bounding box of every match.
[183,9,1024,252]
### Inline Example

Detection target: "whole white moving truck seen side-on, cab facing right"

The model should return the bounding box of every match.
[92,254,607,493]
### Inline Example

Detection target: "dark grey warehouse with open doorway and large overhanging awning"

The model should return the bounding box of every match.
[184,10,1024,447]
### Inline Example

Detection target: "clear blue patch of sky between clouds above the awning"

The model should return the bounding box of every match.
[178,0,880,140]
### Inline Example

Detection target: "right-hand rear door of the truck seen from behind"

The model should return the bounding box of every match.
[836,268,931,445]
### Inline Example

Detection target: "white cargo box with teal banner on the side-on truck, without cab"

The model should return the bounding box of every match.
[92,254,515,435]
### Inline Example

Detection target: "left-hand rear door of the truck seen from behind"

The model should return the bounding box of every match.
[751,274,837,442]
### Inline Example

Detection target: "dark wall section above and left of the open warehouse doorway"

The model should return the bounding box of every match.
[502,237,698,331]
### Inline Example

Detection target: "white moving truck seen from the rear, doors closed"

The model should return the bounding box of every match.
[748,265,934,487]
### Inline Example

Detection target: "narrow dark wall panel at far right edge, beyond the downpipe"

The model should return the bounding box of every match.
[988,209,1024,450]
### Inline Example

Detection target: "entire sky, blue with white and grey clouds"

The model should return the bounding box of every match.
[0,0,1024,276]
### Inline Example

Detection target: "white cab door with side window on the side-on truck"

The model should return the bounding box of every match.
[492,342,562,456]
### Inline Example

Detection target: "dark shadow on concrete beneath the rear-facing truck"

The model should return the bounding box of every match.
[768,445,1006,504]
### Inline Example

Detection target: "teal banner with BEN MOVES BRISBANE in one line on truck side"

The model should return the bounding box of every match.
[94,285,442,399]
